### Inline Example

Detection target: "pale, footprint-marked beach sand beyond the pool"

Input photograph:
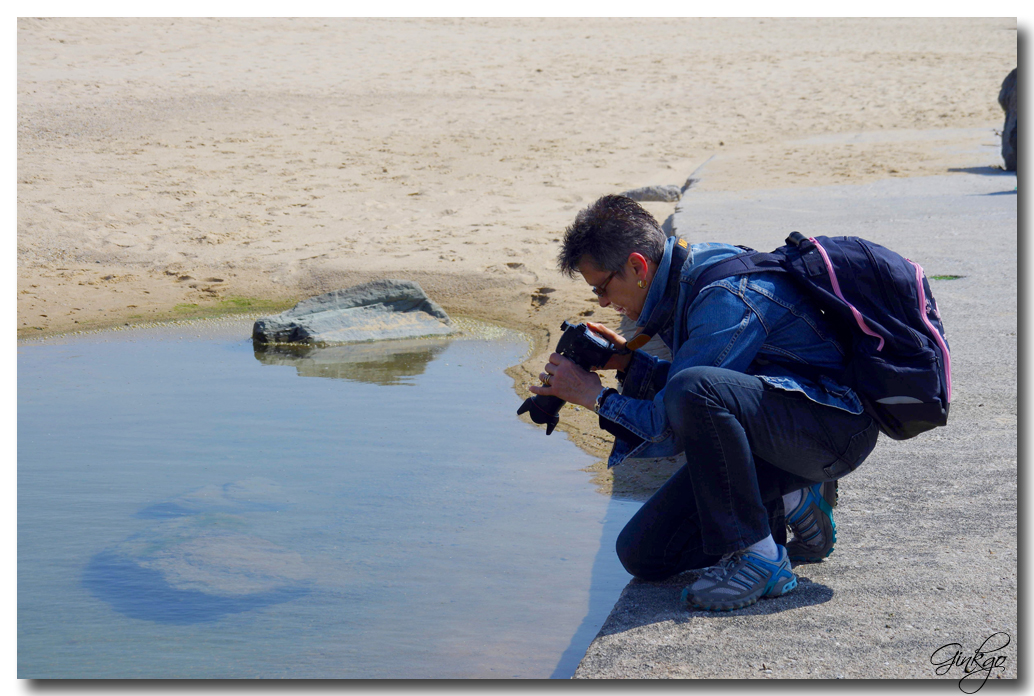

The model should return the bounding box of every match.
[18,19,1016,477]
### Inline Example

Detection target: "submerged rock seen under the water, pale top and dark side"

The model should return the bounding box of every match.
[83,479,312,625]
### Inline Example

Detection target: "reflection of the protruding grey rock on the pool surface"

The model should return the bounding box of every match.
[254,338,449,386]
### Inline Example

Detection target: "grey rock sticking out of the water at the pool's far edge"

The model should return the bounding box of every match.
[251,280,455,344]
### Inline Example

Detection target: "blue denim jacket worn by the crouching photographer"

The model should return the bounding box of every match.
[600,237,862,466]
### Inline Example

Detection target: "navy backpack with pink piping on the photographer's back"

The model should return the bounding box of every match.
[688,232,951,440]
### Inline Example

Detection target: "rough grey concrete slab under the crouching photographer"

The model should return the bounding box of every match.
[575,168,1020,678]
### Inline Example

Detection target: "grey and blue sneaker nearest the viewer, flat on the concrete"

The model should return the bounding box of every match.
[681,546,797,611]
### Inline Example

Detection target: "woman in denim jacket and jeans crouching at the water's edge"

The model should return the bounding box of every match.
[530,195,879,610]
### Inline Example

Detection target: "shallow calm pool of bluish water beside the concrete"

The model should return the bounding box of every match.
[18,322,638,678]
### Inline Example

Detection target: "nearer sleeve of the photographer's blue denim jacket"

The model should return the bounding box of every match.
[600,281,767,443]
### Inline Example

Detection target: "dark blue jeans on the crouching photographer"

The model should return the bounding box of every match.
[617,367,879,580]
